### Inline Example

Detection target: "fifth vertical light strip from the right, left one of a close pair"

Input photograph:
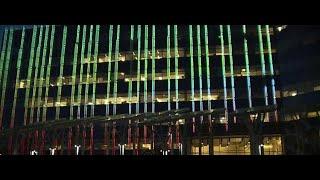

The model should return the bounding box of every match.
[219,25,228,121]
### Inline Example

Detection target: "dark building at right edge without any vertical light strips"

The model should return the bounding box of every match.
[277,25,320,154]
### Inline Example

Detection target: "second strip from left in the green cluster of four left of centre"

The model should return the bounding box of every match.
[77,25,87,119]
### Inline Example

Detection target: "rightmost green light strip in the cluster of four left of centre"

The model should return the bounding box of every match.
[91,25,100,116]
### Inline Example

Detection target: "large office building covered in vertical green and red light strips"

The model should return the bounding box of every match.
[0,25,292,155]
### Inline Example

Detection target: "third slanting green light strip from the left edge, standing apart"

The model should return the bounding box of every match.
[10,26,25,128]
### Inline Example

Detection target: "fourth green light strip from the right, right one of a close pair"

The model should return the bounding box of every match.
[227,25,236,111]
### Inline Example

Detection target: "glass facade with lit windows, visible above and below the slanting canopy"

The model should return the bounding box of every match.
[0,25,282,155]
